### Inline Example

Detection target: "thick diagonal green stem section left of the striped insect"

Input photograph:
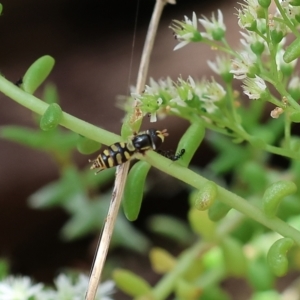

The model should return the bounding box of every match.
[0,76,121,145]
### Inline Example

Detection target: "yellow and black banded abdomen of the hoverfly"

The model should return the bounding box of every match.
[91,142,135,173]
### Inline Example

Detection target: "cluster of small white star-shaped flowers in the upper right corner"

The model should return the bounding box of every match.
[171,0,300,106]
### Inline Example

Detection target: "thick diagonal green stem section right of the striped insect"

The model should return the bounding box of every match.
[141,151,300,245]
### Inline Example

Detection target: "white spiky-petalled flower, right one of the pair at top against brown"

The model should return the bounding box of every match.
[199,9,226,40]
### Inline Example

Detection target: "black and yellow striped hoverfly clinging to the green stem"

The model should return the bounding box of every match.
[89,128,185,173]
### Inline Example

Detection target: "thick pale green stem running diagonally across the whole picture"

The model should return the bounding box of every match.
[0,76,300,245]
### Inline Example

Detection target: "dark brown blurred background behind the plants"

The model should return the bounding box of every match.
[0,0,239,298]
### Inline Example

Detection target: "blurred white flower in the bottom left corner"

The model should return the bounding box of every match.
[0,276,43,300]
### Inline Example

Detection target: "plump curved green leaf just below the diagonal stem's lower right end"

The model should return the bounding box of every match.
[267,238,294,276]
